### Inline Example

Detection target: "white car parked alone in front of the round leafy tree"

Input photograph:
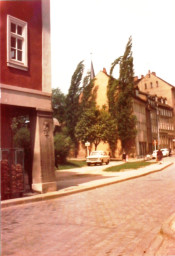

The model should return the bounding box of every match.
[86,150,110,165]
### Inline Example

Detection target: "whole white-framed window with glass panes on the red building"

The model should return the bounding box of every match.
[7,15,28,70]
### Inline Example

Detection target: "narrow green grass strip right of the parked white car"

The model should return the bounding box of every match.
[104,161,154,172]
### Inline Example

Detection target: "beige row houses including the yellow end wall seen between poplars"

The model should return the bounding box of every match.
[80,69,175,158]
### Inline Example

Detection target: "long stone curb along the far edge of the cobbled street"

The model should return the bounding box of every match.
[1,163,173,209]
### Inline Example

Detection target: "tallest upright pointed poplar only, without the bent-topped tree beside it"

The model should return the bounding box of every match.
[116,37,136,151]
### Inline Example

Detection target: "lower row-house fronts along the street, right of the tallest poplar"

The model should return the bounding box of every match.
[133,90,175,156]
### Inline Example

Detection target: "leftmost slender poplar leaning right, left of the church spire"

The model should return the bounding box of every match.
[65,61,84,155]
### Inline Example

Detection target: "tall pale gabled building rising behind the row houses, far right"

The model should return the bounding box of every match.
[135,71,175,152]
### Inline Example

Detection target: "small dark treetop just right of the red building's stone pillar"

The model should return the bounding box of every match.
[52,88,66,123]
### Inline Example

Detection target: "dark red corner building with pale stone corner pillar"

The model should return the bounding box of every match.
[0,0,56,196]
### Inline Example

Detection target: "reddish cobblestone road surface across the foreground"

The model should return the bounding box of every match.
[1,160,175,256]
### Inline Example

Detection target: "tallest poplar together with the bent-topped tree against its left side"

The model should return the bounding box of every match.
[108,37,136,151]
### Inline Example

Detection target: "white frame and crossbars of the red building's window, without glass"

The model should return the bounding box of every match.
[7,15,28,71]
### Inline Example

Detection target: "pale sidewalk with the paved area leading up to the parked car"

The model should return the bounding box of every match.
[1,162,173,208]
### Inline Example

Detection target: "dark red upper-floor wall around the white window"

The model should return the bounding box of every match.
[0,0,42,91]
